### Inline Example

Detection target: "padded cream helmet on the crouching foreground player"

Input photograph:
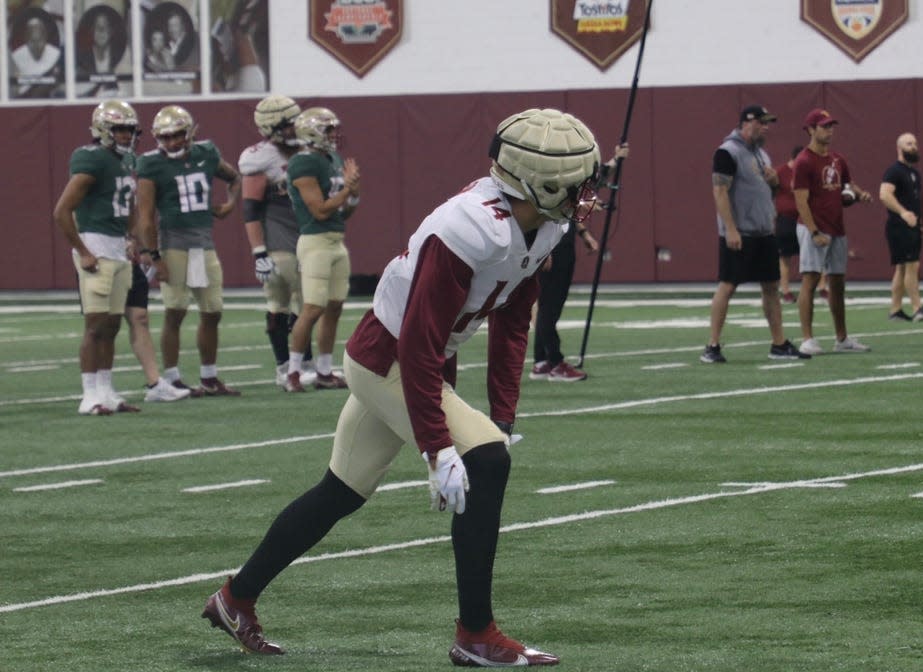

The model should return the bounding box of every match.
[489,108,600,221]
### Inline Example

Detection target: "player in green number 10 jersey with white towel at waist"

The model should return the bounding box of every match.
[138,105,240,396]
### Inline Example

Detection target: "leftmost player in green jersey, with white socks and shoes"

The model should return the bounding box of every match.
[54,100,141,415]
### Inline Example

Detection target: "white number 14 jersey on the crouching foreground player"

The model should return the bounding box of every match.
[373,177,568,357]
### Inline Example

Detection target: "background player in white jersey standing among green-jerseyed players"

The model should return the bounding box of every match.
[237,95,313,391]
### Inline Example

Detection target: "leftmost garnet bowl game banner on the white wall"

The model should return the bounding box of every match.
[308,0,403,77]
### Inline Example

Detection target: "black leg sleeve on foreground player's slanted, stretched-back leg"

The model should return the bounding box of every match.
[231,469,365,600]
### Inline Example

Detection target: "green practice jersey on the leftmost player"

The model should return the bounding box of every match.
[70,144,135,236]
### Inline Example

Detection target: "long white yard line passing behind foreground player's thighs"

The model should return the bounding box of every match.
[0,370,923,478]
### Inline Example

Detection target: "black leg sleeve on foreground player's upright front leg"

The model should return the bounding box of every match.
[452,441,510,632]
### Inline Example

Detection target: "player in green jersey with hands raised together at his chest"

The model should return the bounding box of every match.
[287,107,359,390]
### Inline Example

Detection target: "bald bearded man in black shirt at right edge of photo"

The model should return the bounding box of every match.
[878,133,923,322]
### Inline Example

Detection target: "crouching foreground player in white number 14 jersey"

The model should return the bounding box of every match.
[202,109,600,667]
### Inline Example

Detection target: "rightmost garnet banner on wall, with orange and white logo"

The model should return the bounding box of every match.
[801,0,908,63]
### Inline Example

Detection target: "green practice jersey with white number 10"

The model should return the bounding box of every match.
[138,140,221,230]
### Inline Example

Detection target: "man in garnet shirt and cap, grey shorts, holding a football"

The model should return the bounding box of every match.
[792,109,872,355]
